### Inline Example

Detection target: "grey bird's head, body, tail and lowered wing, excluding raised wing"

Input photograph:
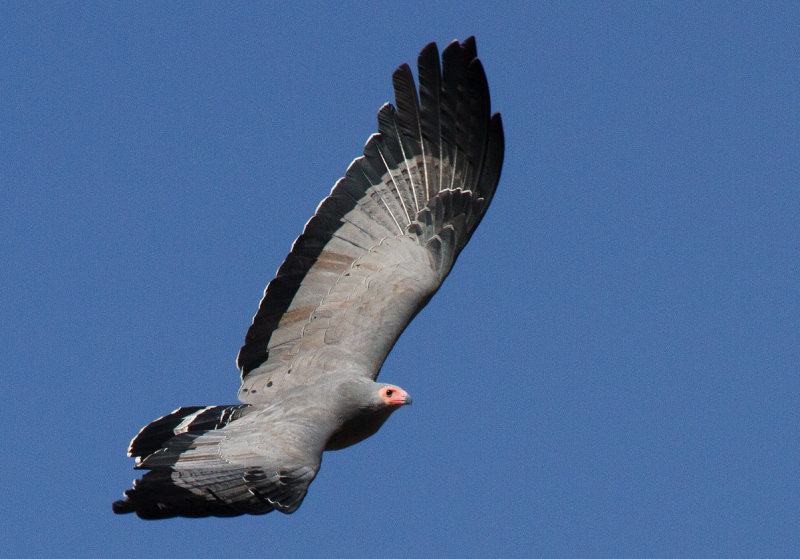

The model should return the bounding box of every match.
[113,376,411,519]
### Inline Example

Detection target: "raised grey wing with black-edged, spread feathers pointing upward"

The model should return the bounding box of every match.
[238,37,504,402]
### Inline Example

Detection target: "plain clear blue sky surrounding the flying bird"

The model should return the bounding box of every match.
[0,0,800,559]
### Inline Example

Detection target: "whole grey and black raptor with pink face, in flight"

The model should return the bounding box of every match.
[112,37,505,519]
